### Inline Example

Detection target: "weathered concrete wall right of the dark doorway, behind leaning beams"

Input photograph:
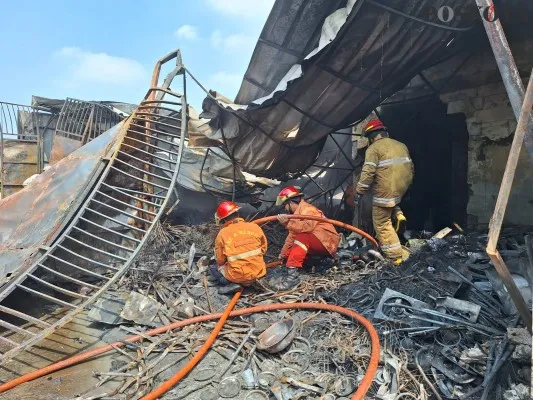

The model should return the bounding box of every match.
[440,82,533,225]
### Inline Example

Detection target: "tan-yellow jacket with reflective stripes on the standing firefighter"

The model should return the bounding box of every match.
[356,138,414,207]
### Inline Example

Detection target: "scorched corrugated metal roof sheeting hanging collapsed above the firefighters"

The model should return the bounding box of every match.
[203,0,475,179]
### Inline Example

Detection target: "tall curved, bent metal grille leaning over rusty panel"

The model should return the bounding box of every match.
[0,64,187,363]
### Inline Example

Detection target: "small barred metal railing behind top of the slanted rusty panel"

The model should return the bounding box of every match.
[56,98,122,144]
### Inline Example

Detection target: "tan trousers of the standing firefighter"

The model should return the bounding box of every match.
[372,204,402,260]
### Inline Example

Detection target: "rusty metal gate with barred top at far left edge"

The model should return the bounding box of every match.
[0,102,44,199]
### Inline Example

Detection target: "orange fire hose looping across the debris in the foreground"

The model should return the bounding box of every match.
[0,304,380,400]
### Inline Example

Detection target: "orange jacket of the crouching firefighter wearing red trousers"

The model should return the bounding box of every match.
[280,200,340,258]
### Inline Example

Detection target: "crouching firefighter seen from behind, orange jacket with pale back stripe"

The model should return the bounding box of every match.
[210,201,267,294]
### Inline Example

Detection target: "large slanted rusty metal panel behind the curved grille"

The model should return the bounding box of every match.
[0,125,120,283]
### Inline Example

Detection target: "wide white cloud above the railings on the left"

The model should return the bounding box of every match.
[57,47,147,87]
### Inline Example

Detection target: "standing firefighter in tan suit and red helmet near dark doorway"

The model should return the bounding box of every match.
[356,119,414,265]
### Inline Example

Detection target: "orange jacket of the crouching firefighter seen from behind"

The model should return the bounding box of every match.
[215,218,267,283]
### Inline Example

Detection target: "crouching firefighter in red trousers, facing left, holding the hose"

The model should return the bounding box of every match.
[270,186,340,290]
